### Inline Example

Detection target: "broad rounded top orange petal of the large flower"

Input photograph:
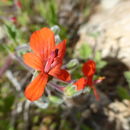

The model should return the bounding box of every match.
[30,28,55,58]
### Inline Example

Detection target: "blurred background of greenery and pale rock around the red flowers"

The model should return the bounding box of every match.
[0,0,130,130]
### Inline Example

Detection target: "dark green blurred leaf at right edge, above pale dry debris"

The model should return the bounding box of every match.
[117,87,130,100]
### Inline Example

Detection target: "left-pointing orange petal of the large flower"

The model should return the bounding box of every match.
[23,53,43,70]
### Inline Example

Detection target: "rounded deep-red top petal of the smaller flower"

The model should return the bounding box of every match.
[82,60,96,77]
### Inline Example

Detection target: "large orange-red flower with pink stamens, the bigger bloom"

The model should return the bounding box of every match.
[24,28,71,101]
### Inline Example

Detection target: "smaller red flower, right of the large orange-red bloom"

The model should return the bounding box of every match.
[74,60,99,99]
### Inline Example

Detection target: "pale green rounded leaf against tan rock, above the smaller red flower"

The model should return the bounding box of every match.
[79,43,92,60]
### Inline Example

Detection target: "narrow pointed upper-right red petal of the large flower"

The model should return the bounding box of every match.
[55,40,66,59]
